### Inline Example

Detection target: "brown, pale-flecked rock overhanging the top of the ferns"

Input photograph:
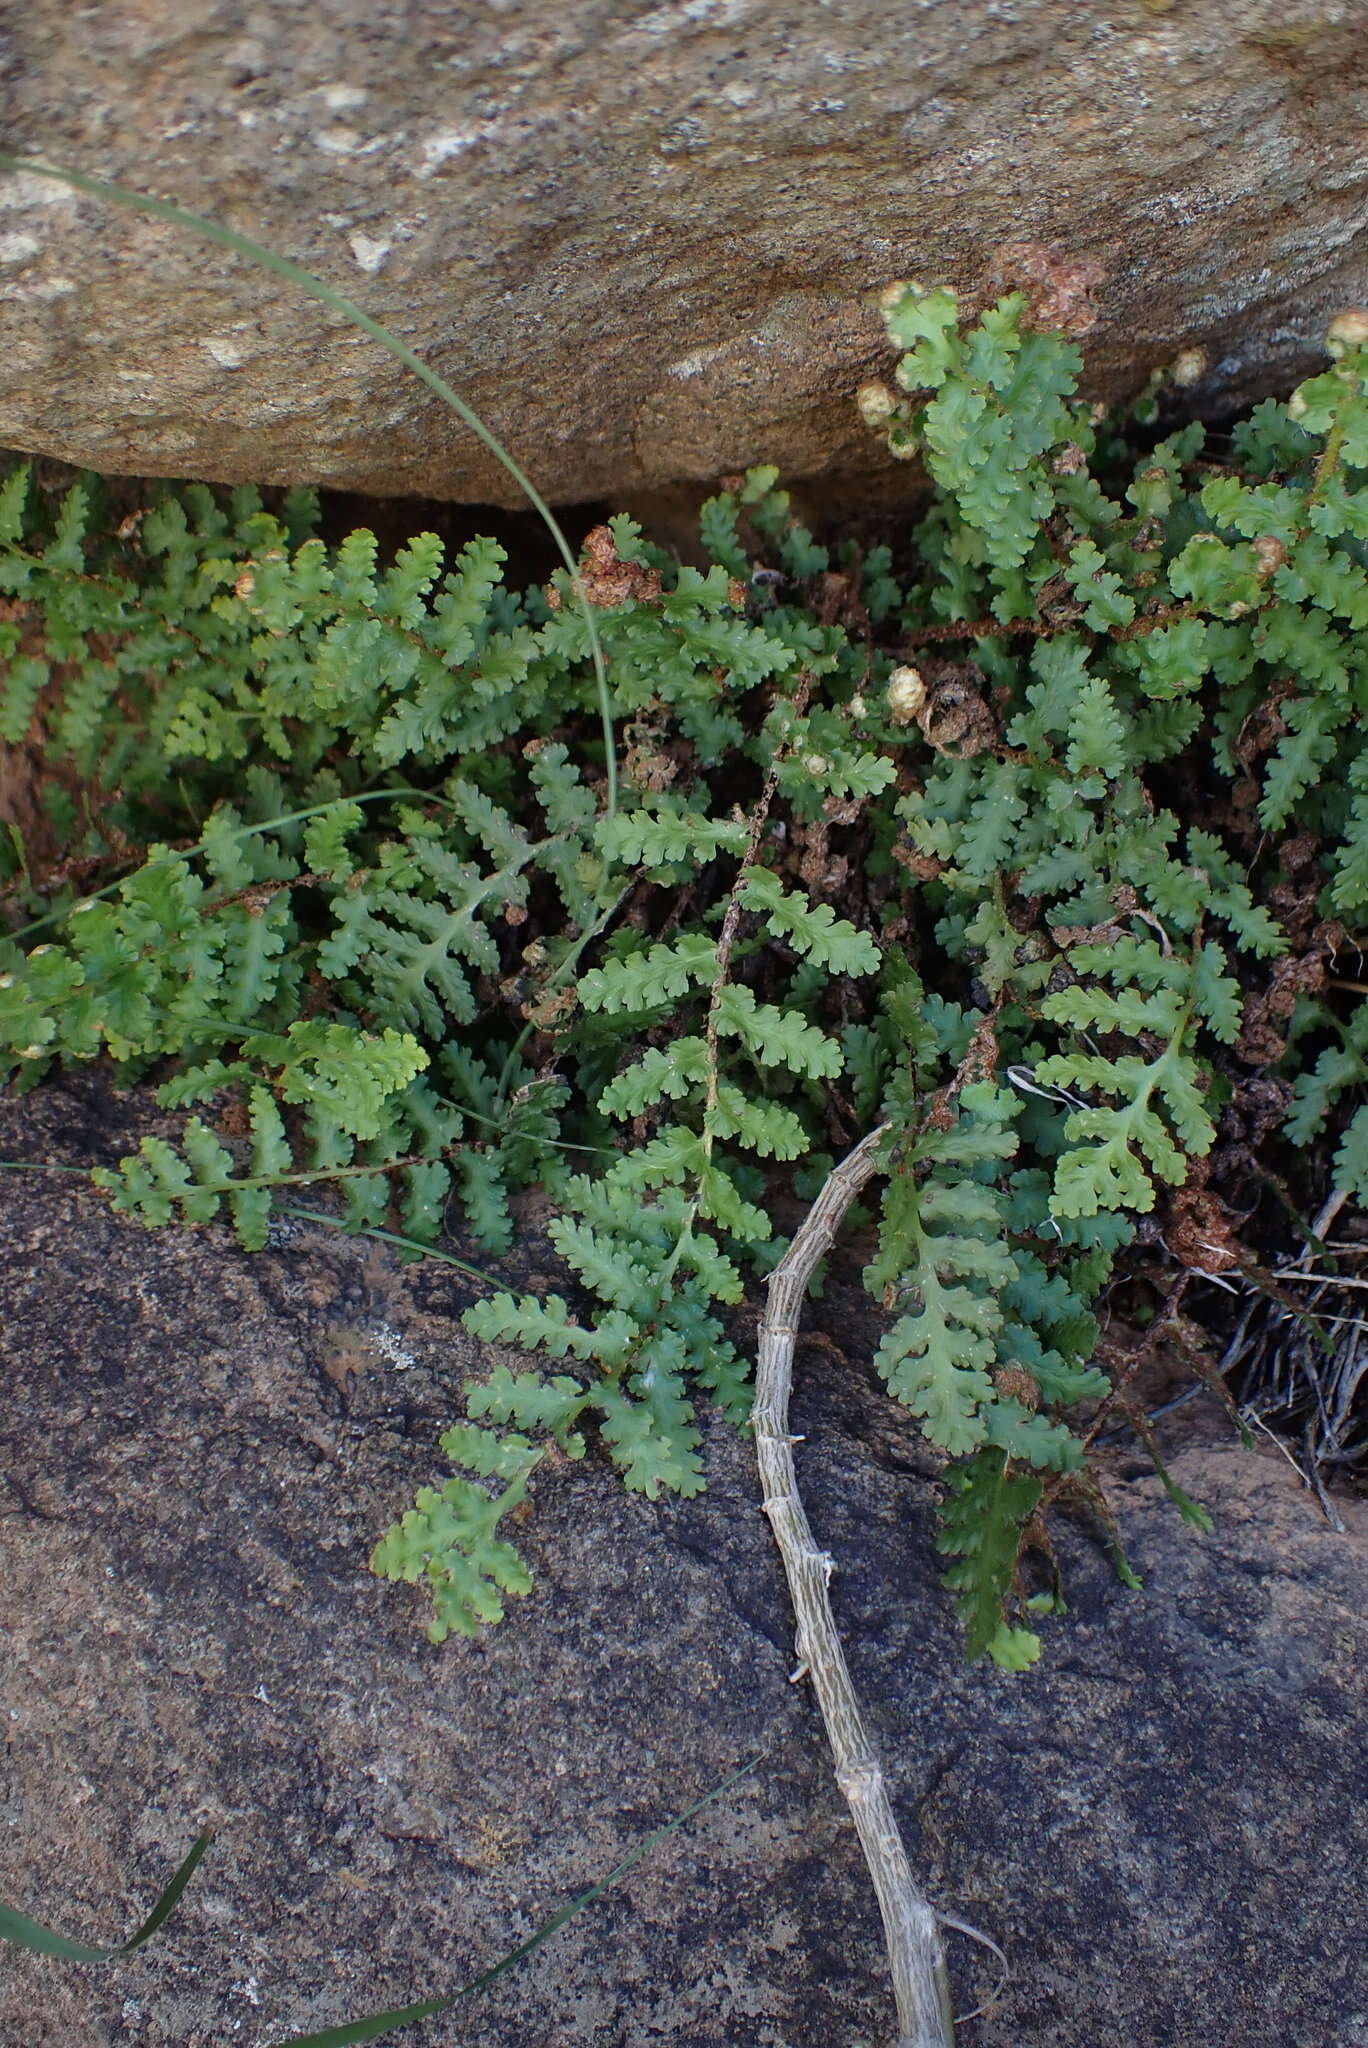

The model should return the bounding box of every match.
[0,0,1368,502]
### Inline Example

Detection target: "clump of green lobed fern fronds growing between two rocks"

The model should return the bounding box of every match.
[0,287,1368,1665]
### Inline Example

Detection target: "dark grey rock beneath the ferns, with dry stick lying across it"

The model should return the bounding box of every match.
[0,1077,1368,2048]
